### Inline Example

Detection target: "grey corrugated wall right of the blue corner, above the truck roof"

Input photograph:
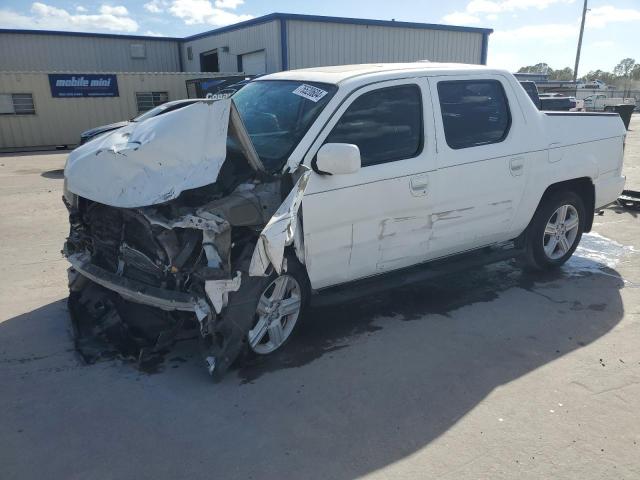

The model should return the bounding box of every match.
[287,20,482,69]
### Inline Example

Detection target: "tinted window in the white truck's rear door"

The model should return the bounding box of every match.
[438,80,511,149]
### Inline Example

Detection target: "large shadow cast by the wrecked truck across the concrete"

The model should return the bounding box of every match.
[0,262,624,479]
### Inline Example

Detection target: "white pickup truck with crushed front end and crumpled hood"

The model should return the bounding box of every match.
[64,63,625,377]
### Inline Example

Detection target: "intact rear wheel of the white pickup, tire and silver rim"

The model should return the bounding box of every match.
[525,192,586,270]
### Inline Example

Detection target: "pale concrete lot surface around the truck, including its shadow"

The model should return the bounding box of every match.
[0,116,640,480]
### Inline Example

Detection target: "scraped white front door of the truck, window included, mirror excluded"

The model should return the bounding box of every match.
[302,79,436,288]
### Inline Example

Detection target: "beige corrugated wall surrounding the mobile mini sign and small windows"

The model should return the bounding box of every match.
[0,72,220,149]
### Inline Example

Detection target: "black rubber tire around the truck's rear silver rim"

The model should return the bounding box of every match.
[525,191,586,270]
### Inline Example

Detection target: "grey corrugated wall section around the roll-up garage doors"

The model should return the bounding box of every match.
[182,20,281,73]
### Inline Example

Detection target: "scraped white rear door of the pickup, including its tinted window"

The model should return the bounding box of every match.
[430,75,544,258]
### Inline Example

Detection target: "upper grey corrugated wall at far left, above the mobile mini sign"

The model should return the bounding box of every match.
[0,33,180,72]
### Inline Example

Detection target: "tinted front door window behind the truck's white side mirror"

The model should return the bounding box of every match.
[325,85,423,167]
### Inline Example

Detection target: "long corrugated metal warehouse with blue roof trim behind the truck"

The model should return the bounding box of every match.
[0,13,492,150]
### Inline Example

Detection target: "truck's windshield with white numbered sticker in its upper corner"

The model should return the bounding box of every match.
[233,80,337,172]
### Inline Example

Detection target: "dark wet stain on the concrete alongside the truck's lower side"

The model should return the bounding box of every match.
[239,261,622,383]
